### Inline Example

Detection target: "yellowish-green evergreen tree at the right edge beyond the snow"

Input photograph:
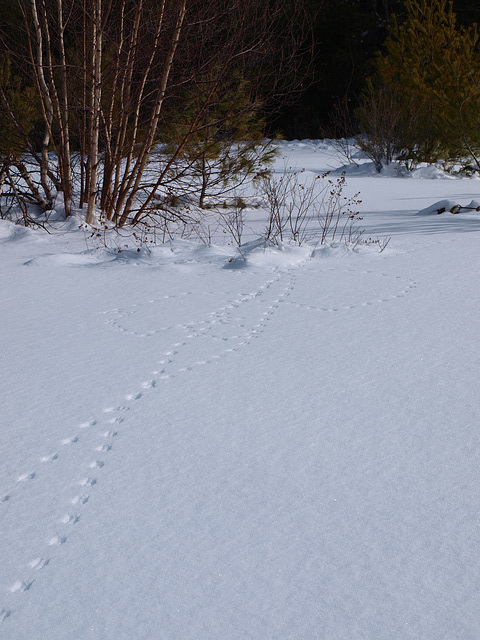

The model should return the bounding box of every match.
[364,0,480,168]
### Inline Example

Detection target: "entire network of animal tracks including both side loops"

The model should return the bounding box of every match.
[0,256,417,621]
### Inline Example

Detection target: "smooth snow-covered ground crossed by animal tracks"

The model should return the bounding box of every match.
[0,141,480,640]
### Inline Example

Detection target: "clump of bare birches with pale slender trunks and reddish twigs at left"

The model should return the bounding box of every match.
[0,0,316,226]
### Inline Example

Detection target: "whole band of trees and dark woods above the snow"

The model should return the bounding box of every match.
[0,0,480,226]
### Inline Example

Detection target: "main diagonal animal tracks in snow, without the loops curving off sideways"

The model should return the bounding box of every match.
[0,273,300,621]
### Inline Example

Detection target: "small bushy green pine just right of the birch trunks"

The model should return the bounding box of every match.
[159,70,275,208]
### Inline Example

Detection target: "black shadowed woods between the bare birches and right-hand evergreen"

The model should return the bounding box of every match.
[270,0,480,138]
